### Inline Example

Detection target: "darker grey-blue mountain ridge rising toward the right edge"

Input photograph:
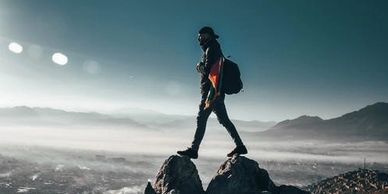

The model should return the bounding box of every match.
[261,102,388,140]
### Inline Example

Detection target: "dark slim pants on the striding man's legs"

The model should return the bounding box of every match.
[191,94,243,150]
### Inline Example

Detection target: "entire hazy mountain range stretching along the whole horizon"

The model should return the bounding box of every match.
[0,102,388,140]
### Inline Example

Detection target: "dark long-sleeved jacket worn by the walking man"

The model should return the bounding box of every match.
[197,39,223,103]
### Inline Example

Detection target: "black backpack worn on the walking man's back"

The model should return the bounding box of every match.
[222,58,243,95]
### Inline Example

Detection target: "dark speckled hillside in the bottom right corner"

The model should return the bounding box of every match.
[307,169,388,194]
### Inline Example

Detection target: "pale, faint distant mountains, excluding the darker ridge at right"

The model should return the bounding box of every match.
[0,106,276,132]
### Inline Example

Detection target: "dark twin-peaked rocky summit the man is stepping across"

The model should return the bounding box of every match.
[145,155,310,194]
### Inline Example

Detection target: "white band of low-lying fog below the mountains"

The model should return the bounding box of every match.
[0,127,388,163]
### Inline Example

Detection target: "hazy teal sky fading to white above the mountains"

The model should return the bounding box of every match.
[0,0,388,121]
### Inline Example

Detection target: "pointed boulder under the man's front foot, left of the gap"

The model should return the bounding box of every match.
[154,155,204,194]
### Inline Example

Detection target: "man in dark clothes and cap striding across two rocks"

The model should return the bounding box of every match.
[177,26,248,159]
